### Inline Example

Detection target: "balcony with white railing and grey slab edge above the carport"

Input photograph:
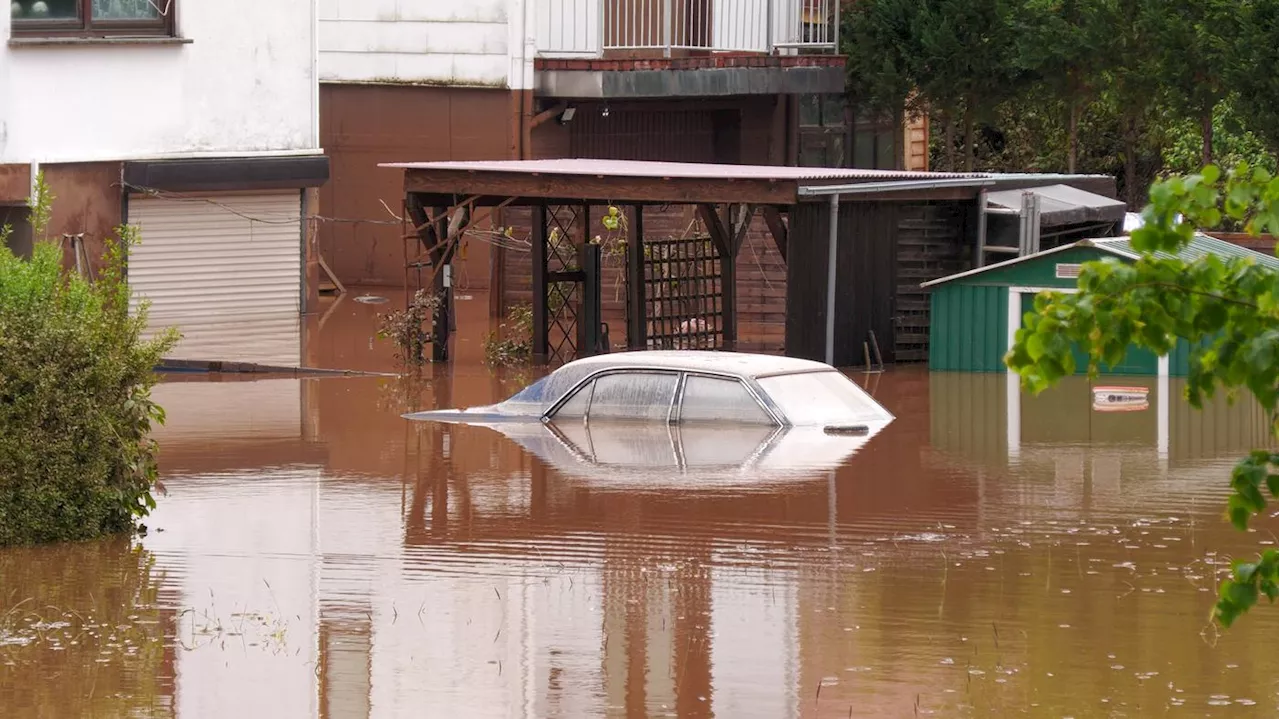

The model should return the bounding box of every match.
[534,0,845,99]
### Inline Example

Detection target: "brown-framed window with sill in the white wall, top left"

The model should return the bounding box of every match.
[10,0,175,37]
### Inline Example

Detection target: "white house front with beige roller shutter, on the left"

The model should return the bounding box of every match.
[0,0,329,365]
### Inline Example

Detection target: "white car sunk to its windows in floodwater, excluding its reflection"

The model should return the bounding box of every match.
[406,349,893,432]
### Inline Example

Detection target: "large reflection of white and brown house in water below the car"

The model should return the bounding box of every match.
[147,368,942,718]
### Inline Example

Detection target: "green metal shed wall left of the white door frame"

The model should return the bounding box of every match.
[929,283,1009,372]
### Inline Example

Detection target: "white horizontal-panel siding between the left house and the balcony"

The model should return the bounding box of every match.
[320,0,512,87]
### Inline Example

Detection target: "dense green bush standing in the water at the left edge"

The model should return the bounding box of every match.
[0,179,178,545]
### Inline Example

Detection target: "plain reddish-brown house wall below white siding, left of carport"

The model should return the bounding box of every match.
[320,84,513,289]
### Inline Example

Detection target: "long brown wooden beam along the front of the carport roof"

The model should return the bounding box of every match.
[404,169,797,205]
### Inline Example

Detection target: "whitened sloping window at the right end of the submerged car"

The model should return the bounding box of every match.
[758,370,893,425]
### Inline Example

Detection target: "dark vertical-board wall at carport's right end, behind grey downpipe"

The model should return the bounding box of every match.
[786,202,899,367]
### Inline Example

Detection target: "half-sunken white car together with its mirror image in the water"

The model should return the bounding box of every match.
[406,351,893,489]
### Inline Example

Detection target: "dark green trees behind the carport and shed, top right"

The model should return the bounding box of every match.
[841,0,1280,198]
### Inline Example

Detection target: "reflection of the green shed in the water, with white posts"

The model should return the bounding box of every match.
[929,372,1271,507]
